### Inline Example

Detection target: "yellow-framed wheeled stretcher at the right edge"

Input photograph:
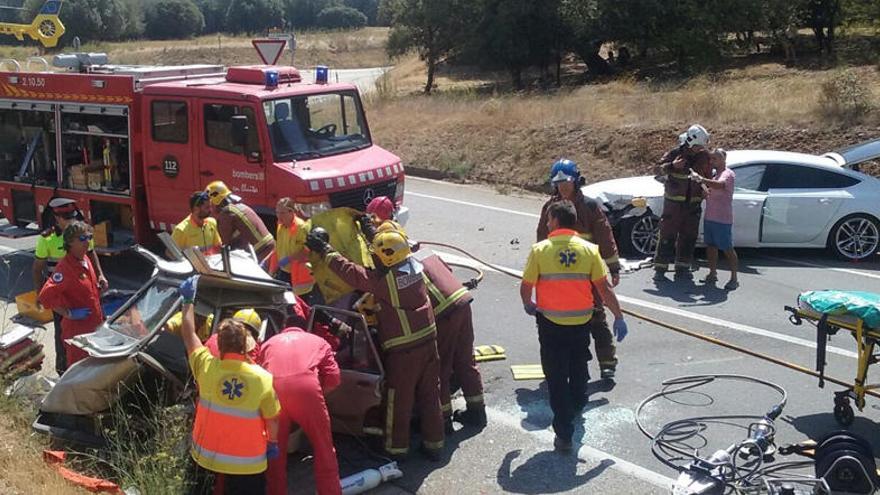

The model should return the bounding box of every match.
[785,295,880,426]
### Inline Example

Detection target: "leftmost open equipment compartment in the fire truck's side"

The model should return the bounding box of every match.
[0,110,58,186]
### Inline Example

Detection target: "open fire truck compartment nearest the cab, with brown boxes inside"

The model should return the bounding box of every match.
[59,103,131,196]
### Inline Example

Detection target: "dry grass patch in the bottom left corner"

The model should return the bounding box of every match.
[0,395,88,495]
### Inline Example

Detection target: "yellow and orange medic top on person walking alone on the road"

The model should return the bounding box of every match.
[523,229,607,325]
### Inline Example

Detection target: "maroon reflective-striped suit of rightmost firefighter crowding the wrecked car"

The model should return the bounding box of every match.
[419,254,483,416]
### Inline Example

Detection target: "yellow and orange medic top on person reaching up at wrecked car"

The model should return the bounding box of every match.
[189,347,281,474]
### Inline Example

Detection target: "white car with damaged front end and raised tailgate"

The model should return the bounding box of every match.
[582,139,880,260]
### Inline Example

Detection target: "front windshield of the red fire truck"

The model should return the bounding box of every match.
[263,91,371,161]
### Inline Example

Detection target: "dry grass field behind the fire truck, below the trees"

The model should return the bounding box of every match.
[0,27,390,69]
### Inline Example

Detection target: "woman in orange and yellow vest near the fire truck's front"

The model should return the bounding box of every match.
[266,198,320,304]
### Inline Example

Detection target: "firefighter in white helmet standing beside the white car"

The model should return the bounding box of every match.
[654,124,712,282]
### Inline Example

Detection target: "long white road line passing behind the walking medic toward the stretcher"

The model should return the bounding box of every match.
[437,251,858,359]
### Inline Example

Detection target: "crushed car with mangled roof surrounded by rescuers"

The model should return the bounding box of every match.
[33,247,384,447]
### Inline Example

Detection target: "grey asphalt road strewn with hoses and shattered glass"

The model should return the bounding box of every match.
[0,177,880,494]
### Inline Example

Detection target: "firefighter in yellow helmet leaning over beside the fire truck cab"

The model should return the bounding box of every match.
[205,180,275,261]
